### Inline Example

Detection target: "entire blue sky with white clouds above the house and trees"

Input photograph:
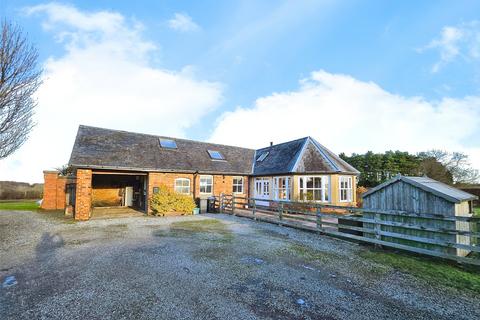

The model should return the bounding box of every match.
[0,0,480,183]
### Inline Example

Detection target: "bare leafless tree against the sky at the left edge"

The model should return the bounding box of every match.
[0,20,41,159]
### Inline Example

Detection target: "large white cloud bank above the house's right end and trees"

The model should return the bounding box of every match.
[210,71,480,169]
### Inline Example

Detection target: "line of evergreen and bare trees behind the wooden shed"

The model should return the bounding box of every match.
[339,150,480,188]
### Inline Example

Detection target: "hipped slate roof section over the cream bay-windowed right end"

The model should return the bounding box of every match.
[253,137,359,175]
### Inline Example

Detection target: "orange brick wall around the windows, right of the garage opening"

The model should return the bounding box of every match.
[148,172,248,212]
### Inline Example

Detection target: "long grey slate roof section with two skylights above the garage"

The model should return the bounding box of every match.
[69,125,255,175]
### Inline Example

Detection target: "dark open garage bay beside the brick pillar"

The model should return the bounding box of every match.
[92,172,147,215]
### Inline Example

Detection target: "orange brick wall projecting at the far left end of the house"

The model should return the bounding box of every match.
[42,171,67,210]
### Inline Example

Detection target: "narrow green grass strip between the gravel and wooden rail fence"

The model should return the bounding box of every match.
[360,250,480,293]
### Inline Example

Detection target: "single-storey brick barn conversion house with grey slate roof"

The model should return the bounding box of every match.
[42,126,359,220]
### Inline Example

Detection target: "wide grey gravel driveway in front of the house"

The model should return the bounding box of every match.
[0,211,480,319]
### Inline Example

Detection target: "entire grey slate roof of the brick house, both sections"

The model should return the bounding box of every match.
[69,125,359,176]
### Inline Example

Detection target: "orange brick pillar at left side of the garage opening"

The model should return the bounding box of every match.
[75,169,92,220]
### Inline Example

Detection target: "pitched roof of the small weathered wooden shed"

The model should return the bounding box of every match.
[363,175,478,203]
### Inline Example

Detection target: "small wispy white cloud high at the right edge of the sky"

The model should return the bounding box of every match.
[419,21,480,72]
